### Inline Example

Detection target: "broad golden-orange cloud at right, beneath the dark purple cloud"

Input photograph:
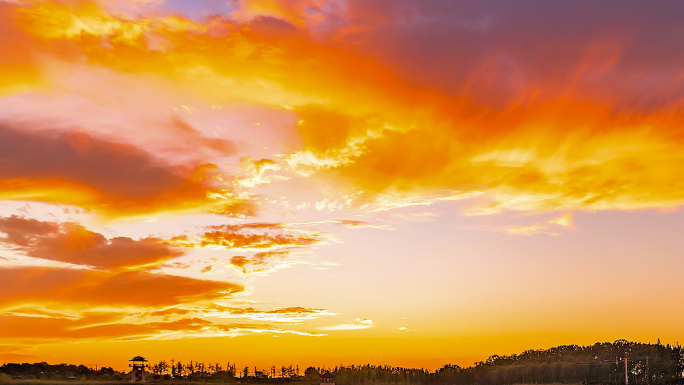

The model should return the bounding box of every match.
[296,102,684,215]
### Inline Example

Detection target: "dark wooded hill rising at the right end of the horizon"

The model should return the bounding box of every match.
[428,340,684,385]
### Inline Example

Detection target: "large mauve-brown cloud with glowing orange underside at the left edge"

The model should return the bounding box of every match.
[0,125,253,218]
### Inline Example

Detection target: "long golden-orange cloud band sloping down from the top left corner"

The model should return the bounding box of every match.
[10,2,410,121]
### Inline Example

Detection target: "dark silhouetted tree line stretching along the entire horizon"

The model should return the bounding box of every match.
[0,340,684,385]
